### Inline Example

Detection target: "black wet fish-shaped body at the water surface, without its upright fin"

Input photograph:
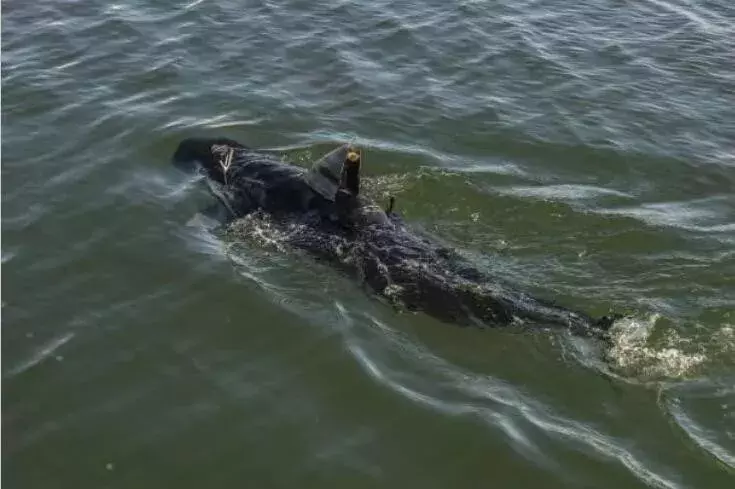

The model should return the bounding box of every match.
[174,135,614,337]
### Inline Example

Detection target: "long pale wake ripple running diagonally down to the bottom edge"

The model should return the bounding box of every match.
[337,305,680,489]
